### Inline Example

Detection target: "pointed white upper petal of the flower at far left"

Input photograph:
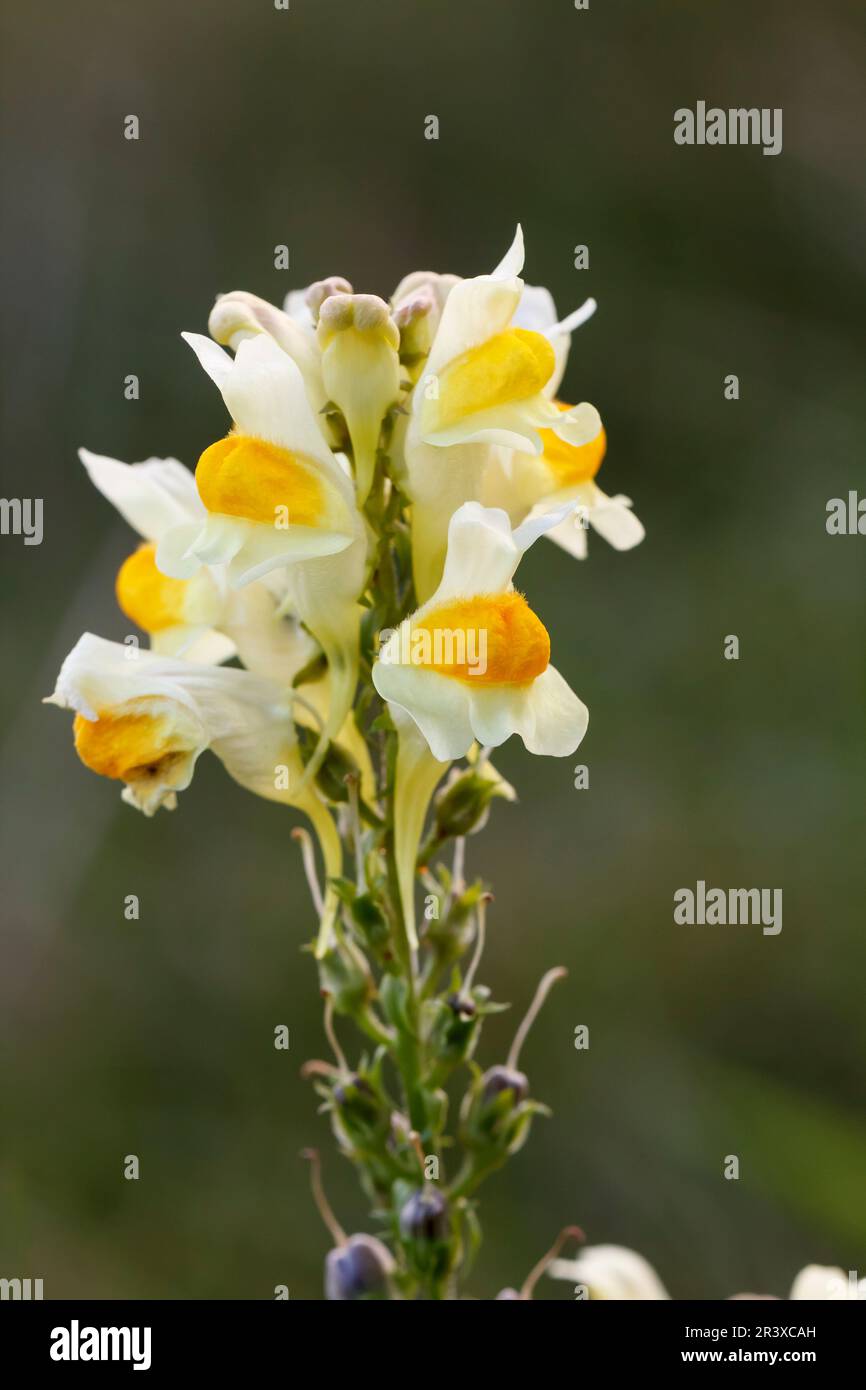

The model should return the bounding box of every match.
[78,449,204,541]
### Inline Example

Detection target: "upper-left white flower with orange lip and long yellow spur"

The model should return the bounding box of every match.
[156,334,367,776]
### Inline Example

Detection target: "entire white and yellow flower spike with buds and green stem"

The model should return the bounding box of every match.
[50,229,644,1297]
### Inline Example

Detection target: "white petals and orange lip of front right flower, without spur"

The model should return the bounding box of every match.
[373,502,589,762]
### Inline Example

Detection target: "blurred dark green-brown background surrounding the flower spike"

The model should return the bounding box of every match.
[0,0,866,1298]
